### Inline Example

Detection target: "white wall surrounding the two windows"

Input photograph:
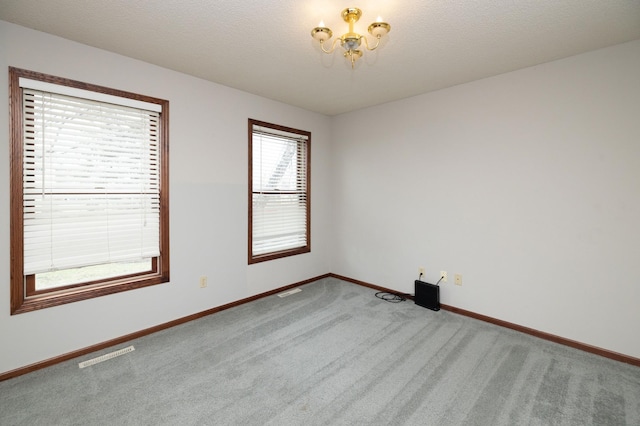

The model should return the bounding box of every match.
[0,21,330,373]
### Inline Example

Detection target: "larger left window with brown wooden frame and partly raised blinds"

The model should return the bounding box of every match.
[9,68,169,314]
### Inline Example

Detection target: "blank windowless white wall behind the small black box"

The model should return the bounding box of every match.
[332,41,640,357]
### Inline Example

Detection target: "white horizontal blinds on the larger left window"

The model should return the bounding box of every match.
[23,88,160,275]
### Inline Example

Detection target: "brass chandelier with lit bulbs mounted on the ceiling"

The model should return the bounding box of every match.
[311,7,391,68]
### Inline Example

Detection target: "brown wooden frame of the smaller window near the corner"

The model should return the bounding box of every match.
[247,118,311,265]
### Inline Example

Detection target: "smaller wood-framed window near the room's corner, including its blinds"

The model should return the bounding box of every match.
[249,119,311,263]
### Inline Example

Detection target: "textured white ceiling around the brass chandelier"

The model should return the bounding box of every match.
[0,0,640,115]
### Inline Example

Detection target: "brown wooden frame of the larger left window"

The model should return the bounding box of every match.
[9,67,169,315]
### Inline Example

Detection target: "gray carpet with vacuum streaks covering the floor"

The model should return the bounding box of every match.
[0,278,640,425]
